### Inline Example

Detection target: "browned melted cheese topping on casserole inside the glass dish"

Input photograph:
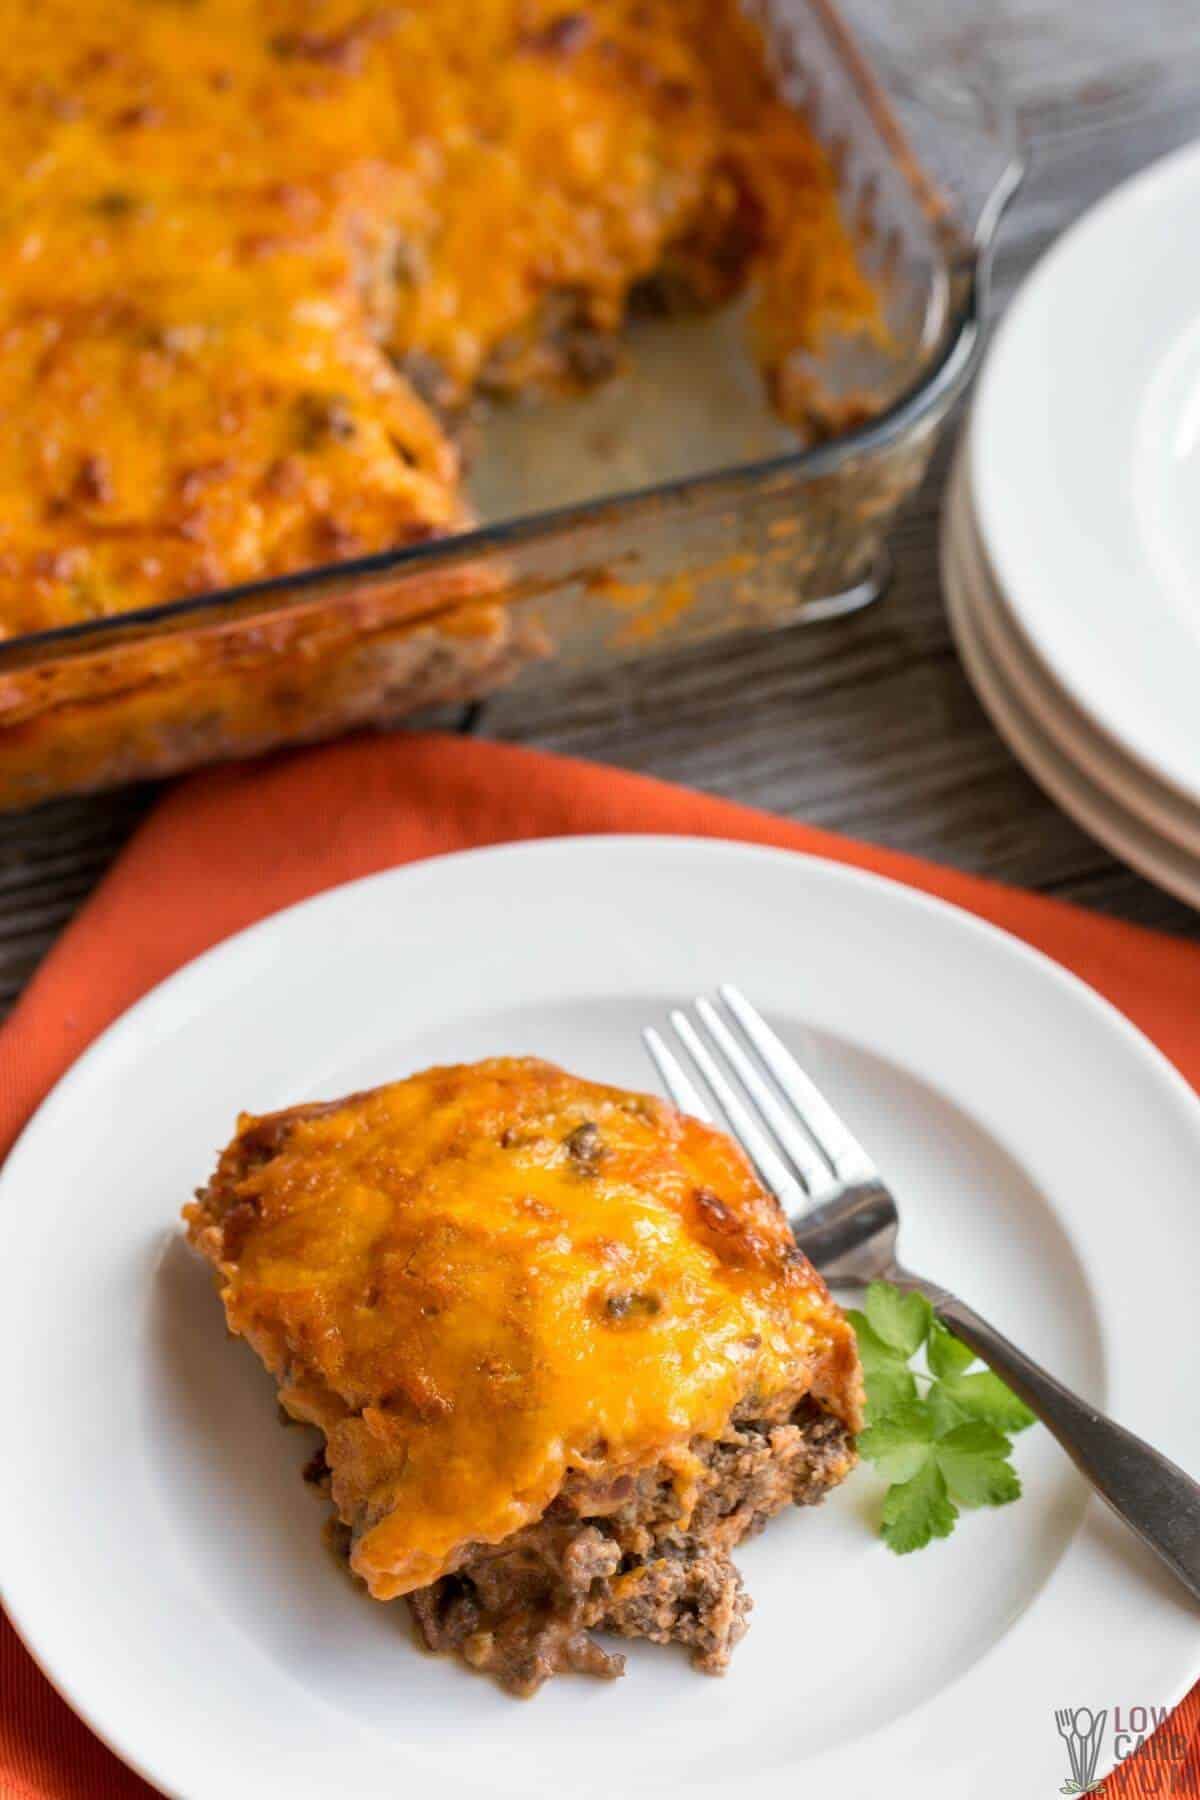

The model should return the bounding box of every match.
[0,0,871,634]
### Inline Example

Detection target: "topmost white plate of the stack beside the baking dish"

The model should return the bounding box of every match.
[968,146,1200,806]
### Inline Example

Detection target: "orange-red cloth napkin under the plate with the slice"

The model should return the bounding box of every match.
[0,736,1200,1800]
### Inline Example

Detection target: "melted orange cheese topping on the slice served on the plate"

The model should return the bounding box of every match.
[189,1058,862,1598]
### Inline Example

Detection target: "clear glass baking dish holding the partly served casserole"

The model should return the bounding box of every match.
[0,0,1018,808]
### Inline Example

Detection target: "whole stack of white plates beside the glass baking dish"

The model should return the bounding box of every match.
[943,136,1200,905]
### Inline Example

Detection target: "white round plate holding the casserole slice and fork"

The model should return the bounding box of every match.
[0,837,1200,1800]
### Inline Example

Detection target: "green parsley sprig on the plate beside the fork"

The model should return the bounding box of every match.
[847,1282,1034,1555]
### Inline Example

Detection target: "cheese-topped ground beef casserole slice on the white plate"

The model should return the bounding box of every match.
[185,1058,862,1694]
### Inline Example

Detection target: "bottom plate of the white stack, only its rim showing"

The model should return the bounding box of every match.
[941,468,1200,907]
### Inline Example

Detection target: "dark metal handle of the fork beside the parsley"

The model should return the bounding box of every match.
[914,1282,1200,1600]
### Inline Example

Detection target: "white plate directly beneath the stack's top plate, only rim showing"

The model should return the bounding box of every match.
[943,452,1200,859]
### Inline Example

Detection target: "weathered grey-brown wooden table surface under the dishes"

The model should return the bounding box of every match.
[0,0,1200,1010]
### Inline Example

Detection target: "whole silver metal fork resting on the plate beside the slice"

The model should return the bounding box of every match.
[642,986,1200,1600]
